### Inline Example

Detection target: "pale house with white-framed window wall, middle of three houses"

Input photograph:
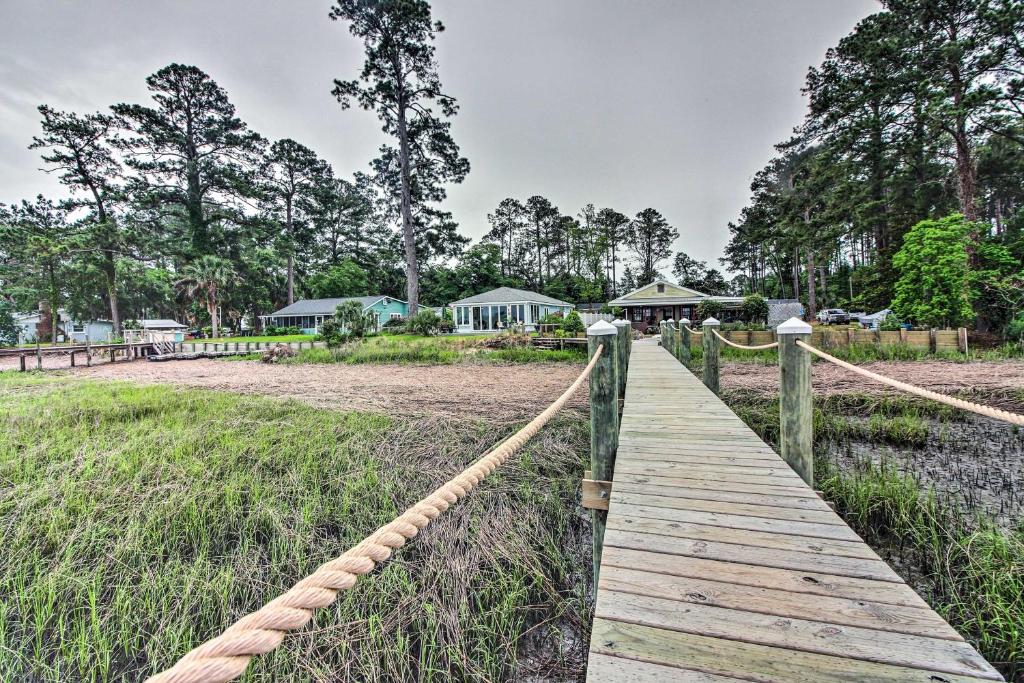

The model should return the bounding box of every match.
[449,287,572,334]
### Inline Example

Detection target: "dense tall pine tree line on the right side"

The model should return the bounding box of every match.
[722,0,1024,330]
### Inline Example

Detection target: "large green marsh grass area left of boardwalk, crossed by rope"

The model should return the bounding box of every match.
[0,374,590,682]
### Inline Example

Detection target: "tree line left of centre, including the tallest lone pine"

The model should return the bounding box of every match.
[0,0,469,334]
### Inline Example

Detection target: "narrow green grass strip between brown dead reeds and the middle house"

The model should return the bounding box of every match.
[283,335,587,365]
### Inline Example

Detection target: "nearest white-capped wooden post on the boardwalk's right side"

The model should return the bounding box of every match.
[778,317,814,487]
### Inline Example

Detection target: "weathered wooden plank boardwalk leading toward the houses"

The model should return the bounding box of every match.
[587,342,1002,683]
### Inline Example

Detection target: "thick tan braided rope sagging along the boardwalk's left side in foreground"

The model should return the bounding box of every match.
[146,344,604,683]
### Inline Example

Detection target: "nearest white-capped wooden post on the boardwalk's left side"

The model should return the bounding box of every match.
[587,321,618,586]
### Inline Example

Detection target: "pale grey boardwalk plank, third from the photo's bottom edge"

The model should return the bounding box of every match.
[595,591,998,680]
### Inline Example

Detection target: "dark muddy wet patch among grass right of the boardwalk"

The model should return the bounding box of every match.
[827,416,1024,525]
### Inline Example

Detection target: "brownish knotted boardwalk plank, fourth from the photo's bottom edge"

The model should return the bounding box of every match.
[600,565,964,641]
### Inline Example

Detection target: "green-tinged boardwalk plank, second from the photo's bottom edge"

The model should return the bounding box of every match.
[591,618,992,683]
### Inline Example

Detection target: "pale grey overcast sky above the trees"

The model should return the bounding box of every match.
[0,0,879,271]
